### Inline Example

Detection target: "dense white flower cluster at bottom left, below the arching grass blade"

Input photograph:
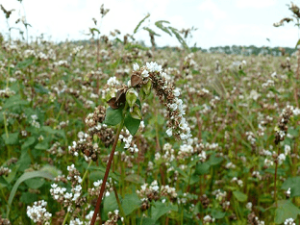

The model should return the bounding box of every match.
[27,200,52,225]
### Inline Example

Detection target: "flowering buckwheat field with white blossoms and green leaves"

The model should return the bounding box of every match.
[0,1,300,225]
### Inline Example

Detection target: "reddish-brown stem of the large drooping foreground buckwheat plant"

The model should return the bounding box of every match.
[91,110,127,225]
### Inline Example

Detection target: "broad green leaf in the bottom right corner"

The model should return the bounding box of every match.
[274,200,300,224]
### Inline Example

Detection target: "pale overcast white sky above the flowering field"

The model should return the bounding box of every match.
[0,0,300,48]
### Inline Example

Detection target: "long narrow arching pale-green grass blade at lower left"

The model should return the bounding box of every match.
[6,171,54,218]
